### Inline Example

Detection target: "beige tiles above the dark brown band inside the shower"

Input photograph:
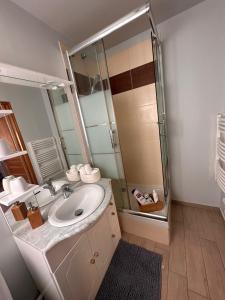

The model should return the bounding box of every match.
[106,31,153,77]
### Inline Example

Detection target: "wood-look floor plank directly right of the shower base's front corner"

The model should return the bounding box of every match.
[169,222,186,276]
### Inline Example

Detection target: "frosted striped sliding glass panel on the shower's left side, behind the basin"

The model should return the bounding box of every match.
[70,41,126,208]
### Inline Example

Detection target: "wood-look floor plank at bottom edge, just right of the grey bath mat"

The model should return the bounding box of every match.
[167,272,188,300]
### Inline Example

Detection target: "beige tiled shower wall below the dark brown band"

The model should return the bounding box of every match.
[113,84,163,186]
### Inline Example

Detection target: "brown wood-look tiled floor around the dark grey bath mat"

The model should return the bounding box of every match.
[123,205,225,300]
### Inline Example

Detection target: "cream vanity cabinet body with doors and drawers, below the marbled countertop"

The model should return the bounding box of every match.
[16,197,121,300]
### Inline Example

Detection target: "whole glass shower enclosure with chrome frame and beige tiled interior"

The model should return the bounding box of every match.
[63,5,169,220]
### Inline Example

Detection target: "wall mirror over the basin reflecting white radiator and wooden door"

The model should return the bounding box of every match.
[0,83,83,226]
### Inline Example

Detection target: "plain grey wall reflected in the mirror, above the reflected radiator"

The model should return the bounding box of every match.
[0,83,53,143]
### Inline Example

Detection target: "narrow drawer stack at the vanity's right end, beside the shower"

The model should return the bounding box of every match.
[106,196,121,250]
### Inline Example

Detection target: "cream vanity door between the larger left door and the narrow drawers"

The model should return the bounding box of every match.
[88,213,114,281]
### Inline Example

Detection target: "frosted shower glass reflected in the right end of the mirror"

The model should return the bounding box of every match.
[48,88,83,167]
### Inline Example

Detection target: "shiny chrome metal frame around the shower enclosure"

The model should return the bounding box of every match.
[64,3,170,220]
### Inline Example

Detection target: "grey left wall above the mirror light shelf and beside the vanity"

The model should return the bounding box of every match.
[0,0,66,300]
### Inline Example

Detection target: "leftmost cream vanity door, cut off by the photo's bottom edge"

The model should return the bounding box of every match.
[55,234,99,300]
